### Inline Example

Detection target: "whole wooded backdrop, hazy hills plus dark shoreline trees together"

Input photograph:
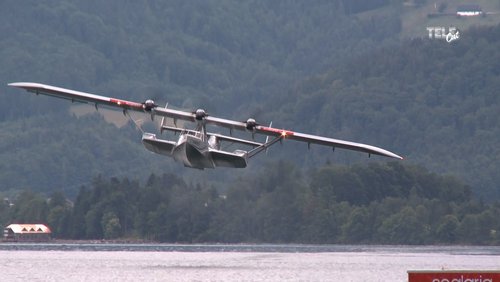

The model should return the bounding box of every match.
[0,0,500,244]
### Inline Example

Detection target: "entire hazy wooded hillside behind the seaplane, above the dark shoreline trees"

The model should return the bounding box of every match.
[0,0,500,199]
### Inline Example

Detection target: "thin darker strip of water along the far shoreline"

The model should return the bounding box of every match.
[0,240,500,256]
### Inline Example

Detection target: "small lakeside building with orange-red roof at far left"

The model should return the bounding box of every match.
[3,224,52,242]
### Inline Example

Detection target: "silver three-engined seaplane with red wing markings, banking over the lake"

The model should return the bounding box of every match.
[8,82,403,170]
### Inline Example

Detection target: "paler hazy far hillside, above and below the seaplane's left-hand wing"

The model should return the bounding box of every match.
[0,0,400,195]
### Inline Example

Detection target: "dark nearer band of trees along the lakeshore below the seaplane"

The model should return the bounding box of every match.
[0,162,500,244]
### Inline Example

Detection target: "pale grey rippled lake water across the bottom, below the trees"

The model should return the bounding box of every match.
[0,243,500,281]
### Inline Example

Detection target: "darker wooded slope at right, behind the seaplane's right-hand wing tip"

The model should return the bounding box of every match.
[281,26,500,197]
